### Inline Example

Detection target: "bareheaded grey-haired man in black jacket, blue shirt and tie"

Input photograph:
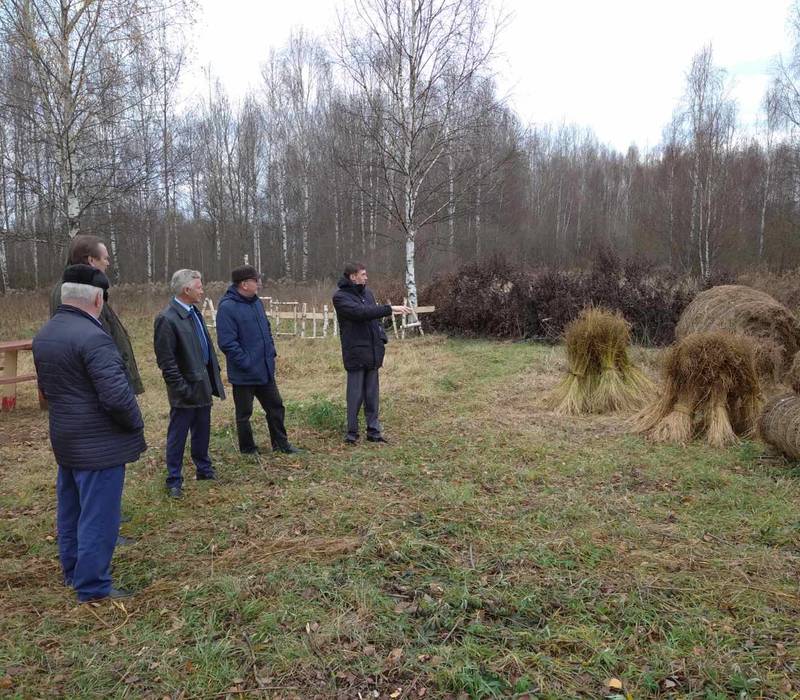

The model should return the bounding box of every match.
[153,270,225,498]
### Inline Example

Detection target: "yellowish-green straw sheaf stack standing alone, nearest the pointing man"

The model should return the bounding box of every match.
[547,307,653,415]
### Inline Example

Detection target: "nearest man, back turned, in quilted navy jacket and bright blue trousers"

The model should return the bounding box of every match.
[33,265,146,602]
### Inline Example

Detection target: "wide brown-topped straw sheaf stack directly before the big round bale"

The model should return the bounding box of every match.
[633,332,762,447]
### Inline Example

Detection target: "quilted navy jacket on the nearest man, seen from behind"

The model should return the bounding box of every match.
[33,305,147,470]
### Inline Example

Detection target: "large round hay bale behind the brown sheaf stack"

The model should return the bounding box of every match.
[675,284,800,381]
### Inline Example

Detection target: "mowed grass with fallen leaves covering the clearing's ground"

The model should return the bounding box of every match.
[0,296,800,699]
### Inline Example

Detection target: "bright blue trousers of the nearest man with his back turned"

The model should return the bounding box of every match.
[56,464,125,602]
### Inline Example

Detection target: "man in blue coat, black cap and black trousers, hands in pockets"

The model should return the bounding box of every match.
[217,265,300,454]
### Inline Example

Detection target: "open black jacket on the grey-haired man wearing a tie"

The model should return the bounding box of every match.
[153,299,225,408]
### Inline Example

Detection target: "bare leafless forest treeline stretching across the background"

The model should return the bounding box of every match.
[0,0,800,299]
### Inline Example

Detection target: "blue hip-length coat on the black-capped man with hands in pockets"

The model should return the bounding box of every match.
[217,285,277,386]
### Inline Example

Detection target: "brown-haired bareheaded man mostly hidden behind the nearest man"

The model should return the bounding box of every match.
[50,234,144,394]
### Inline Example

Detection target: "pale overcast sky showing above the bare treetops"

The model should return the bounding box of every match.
[189,0,791,150]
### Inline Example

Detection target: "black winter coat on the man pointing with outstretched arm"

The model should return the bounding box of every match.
[333,277,392,370]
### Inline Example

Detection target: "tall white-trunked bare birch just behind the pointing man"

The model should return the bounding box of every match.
[337,0,496,306]
